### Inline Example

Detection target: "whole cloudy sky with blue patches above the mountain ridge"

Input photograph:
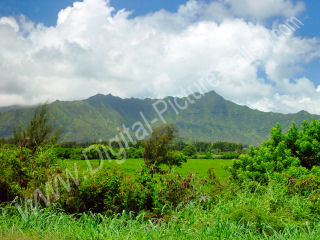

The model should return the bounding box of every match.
[0,0,320,114]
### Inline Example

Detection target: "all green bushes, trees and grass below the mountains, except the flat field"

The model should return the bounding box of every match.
[0,104,320,239]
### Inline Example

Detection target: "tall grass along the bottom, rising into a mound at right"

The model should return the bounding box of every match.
[0,185,320,240]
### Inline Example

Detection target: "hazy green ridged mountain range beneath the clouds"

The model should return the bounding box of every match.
[0,91,320,145]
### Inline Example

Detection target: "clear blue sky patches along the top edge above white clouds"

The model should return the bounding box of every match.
[0,0,320,37]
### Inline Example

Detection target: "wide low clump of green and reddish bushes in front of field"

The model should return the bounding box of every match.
[59,169,197,215]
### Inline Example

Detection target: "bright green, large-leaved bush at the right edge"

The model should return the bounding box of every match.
[230,120,320,183]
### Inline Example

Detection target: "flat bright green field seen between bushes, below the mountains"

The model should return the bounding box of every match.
[60,159,233,180]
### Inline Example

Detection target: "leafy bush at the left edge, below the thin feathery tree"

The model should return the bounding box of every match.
[0,146,57,202]
